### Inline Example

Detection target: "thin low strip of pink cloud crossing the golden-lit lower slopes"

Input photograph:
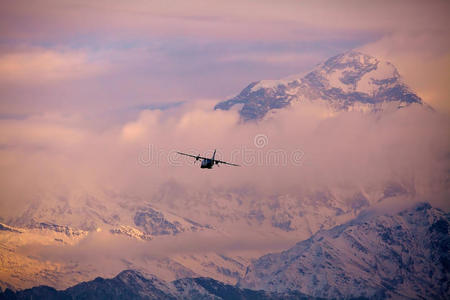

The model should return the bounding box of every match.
[18,231,296,264]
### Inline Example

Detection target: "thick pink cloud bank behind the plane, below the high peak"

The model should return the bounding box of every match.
[2,101,449,218]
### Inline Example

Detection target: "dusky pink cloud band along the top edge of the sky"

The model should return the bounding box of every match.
[2,0,448,40]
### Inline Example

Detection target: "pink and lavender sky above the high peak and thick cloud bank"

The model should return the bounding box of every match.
[0,0,450,118]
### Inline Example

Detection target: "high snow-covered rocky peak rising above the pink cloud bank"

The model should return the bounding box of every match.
[215,51,422,120]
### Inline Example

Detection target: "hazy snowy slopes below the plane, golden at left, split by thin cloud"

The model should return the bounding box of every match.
[0,178,418,288]
